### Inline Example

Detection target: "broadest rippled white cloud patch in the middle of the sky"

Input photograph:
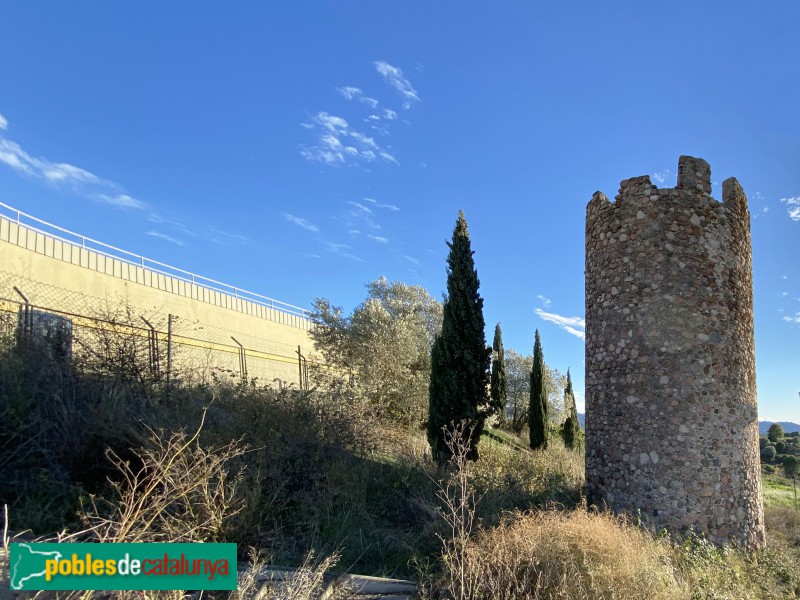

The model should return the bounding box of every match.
[300,111,397,166]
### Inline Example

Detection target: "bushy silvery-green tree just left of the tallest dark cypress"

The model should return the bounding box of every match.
[311,277,442,425]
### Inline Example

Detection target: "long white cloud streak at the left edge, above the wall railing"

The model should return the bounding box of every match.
[0,115,147,210]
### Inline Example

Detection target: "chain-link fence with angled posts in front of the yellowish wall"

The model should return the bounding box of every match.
[0,270,326,389]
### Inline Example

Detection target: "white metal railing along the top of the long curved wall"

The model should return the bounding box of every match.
[0,202,310,319]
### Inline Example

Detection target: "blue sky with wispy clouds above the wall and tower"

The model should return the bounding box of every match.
[0,0,800,421]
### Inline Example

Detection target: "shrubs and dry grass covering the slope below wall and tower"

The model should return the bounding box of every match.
[0,268,800,599]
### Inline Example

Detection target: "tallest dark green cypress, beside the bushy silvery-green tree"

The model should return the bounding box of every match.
[428,211,492,462]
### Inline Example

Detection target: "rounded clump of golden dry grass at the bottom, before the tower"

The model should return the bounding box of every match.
[428,510,686,600]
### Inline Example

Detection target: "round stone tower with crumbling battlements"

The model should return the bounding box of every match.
[586,156,764,548]
